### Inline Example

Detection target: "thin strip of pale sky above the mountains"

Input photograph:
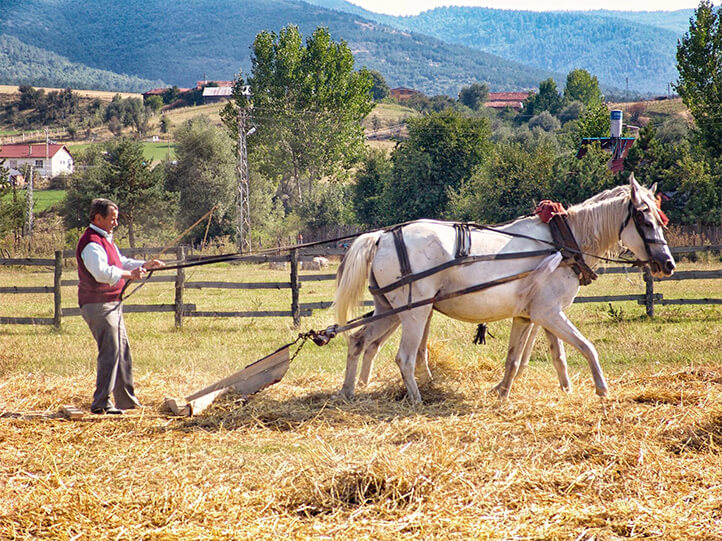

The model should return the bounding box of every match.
[350,0,700,15]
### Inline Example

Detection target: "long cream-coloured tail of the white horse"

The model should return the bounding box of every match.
[333,231,383,325]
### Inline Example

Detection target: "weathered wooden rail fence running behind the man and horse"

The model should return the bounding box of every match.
[0,245,722,328]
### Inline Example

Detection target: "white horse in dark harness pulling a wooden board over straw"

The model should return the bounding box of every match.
[334,176,675,403]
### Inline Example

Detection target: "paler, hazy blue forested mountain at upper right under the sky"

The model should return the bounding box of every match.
[309,0,693,94]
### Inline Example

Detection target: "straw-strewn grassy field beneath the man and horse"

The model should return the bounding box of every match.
[0,260,722,540]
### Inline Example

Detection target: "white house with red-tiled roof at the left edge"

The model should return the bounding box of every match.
[0,143,74,178]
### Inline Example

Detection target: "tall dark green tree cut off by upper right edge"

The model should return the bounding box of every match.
[674,0,722,158]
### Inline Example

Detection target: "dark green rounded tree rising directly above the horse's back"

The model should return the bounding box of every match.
[383,109,491,223]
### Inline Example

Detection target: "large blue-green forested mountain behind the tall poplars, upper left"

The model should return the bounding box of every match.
[0,0,565,96]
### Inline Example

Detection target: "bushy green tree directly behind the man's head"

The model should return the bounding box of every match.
[62,138,176,247]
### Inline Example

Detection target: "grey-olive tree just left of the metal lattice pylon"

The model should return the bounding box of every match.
[166,116,236,238]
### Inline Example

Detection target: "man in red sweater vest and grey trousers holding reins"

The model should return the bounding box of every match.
[75,199,165,415]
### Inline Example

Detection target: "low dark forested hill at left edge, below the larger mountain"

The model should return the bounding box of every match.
[0,34,163,92]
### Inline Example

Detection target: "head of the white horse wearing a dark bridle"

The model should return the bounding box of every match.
[619,174,675,278]
